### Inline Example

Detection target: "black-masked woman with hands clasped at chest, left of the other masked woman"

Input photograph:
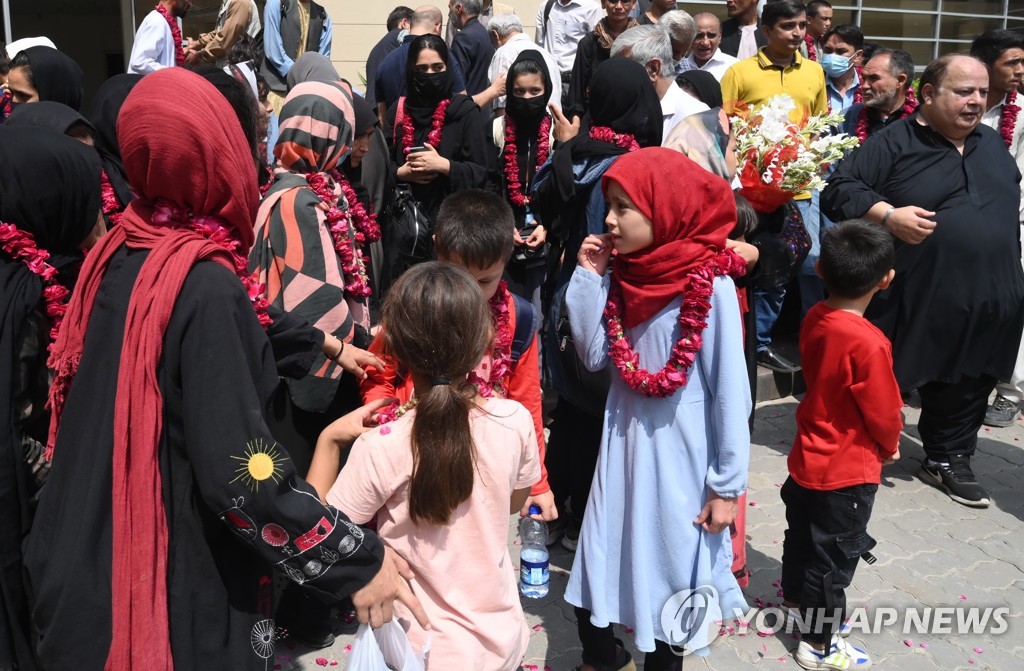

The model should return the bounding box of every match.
[387,35,487,241]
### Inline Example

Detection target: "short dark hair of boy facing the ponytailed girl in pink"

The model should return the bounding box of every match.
[434,188,515,268]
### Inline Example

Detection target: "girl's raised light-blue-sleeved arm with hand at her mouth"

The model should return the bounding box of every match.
[565,236,611,371]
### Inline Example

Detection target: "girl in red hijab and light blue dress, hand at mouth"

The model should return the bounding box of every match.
[565,148,751,671]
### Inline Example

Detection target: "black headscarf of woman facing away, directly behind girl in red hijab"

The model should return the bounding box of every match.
[553,57,663,201]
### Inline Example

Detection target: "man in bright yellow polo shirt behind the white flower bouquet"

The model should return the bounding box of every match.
[722,0,828,373]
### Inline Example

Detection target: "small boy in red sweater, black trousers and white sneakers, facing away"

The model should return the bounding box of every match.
[782,219,903,670]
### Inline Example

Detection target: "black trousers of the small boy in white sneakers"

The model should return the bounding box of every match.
[782,477,879,643]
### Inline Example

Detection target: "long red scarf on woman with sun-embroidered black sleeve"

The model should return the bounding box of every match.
[49,68,257,671]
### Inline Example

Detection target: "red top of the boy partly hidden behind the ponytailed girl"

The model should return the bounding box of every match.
[359,294,551,496]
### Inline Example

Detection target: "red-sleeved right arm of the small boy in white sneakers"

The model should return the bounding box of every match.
[850,349,903,460]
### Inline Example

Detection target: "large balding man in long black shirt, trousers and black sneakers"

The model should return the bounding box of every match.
[821,55,1024,507]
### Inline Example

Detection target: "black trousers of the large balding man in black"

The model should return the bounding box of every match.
[918,375,996,461]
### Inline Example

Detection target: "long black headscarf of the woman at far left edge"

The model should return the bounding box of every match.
[0,126,99,669]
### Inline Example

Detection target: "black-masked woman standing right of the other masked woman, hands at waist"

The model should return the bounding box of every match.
[494,49,553,310]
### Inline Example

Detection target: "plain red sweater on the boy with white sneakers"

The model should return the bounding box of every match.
[788,302,903,490]
